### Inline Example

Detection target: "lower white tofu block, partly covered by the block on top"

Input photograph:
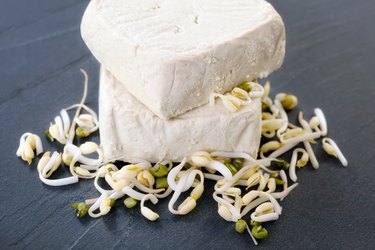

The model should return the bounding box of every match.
[99,69,261,162]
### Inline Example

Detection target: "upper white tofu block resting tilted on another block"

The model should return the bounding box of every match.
[81,0,285,119]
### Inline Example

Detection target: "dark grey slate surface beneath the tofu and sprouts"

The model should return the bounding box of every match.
[0,0,375,249]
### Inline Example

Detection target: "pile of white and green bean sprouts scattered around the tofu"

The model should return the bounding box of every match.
[17,70,348,245]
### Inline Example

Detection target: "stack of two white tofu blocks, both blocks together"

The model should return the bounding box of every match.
[81,0,285,162]
